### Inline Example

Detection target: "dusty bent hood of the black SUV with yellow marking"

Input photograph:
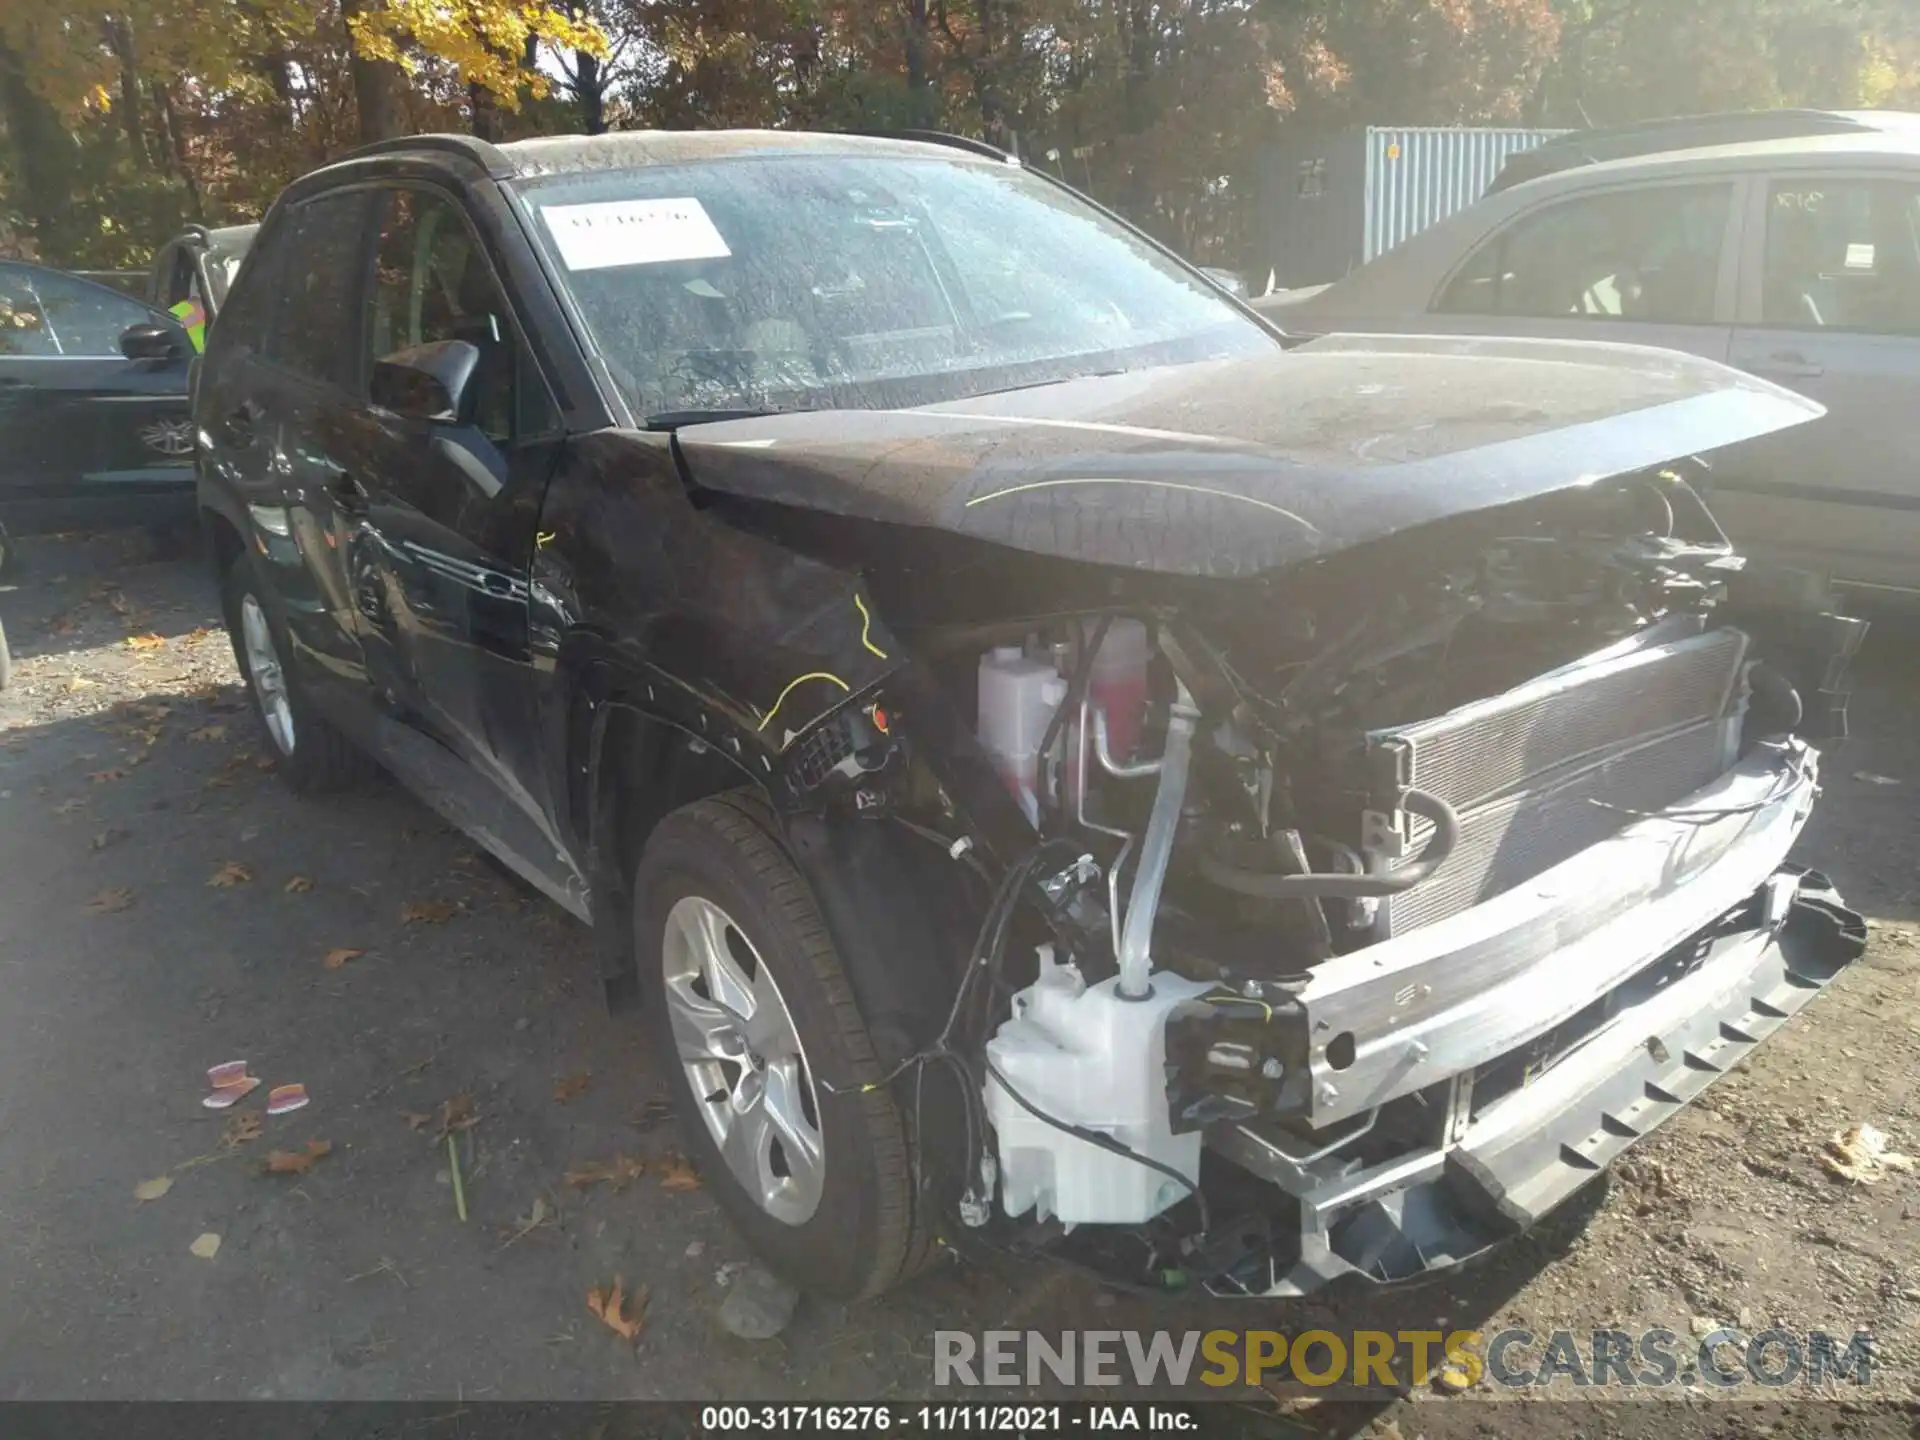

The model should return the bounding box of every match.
[678,336,1822,576]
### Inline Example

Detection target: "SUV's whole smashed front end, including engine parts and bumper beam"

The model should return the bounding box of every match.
[760,470,1864,1296]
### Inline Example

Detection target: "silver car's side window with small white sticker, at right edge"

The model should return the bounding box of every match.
[1761,177,1920,336]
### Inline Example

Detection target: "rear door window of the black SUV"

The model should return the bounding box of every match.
[267,190,372,390]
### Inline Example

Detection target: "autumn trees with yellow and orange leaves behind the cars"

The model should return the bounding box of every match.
[0,0,1920,267]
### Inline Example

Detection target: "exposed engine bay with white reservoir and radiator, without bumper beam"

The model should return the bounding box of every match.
[771,470,1862,1288]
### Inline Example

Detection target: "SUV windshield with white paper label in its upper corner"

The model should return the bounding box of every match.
[522,156,1277,415]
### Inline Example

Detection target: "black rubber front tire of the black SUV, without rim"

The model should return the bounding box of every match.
[634,793,929,1300]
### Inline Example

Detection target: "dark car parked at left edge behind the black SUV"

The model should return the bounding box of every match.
[0,261,194,549]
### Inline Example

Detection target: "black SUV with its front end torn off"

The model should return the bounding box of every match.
[196,132,1860,1296]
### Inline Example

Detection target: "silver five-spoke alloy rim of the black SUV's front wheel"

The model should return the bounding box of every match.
[660,895,826,1225]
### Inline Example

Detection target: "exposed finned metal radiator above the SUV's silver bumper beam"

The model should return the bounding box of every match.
[1367,630,1747,935]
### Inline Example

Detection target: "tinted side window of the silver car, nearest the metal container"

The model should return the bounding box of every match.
[1436,184,1734,324]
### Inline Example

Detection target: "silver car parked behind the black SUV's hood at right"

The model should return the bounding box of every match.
[1254,113,1920,591]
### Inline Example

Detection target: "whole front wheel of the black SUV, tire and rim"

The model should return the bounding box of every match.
[634,795,927,1300]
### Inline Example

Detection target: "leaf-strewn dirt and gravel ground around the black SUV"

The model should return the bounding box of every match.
[0,536,1920,1440]
